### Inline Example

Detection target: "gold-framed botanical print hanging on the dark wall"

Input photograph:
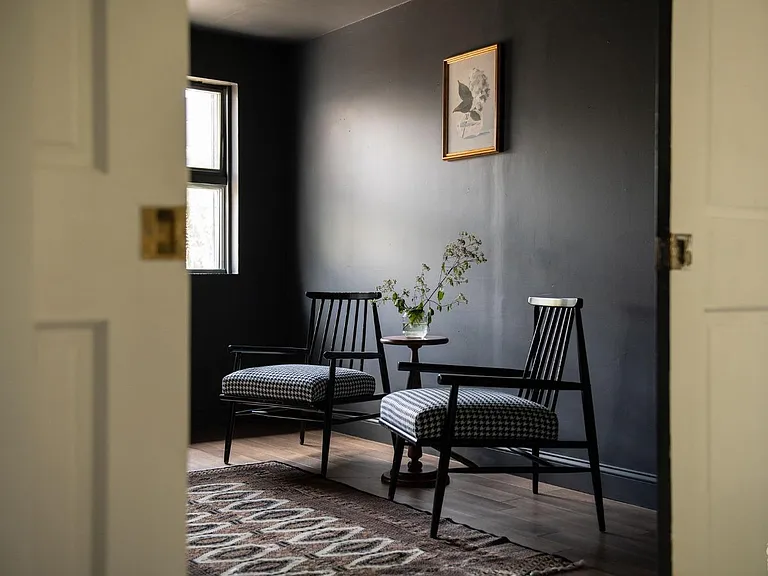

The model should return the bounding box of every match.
[443,44,503,160]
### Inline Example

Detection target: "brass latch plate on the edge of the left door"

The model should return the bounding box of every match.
[141,206,187,260]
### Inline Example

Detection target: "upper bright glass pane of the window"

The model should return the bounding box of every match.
[187,88,221,170]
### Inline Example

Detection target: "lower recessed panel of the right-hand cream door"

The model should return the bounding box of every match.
[707,312,768,576]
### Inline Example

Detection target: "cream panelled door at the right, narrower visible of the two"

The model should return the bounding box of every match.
[670,0,768,576]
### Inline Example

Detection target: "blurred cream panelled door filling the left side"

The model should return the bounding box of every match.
[0,0,189,576]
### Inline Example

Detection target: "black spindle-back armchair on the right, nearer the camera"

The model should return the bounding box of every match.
[379,298,605,538]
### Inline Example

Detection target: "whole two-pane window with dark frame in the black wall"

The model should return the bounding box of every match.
[186,79,236,274]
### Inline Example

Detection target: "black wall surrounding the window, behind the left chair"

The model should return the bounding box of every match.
[190,27,302,441]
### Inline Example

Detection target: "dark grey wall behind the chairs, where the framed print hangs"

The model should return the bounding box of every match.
[298,0,657,505]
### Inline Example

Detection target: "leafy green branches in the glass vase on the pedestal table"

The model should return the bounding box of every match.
[376,232,487,324]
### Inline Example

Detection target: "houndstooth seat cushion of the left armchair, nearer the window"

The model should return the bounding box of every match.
[221,364,376,404]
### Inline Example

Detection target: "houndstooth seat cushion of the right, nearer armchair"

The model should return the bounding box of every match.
[379,388,558,441]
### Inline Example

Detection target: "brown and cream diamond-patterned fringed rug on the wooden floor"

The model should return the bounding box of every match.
[187,462,581,576]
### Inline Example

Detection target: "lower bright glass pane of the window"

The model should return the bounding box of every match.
[187,184,226,270]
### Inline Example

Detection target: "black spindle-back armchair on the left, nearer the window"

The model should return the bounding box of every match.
[220,292,390,477]
